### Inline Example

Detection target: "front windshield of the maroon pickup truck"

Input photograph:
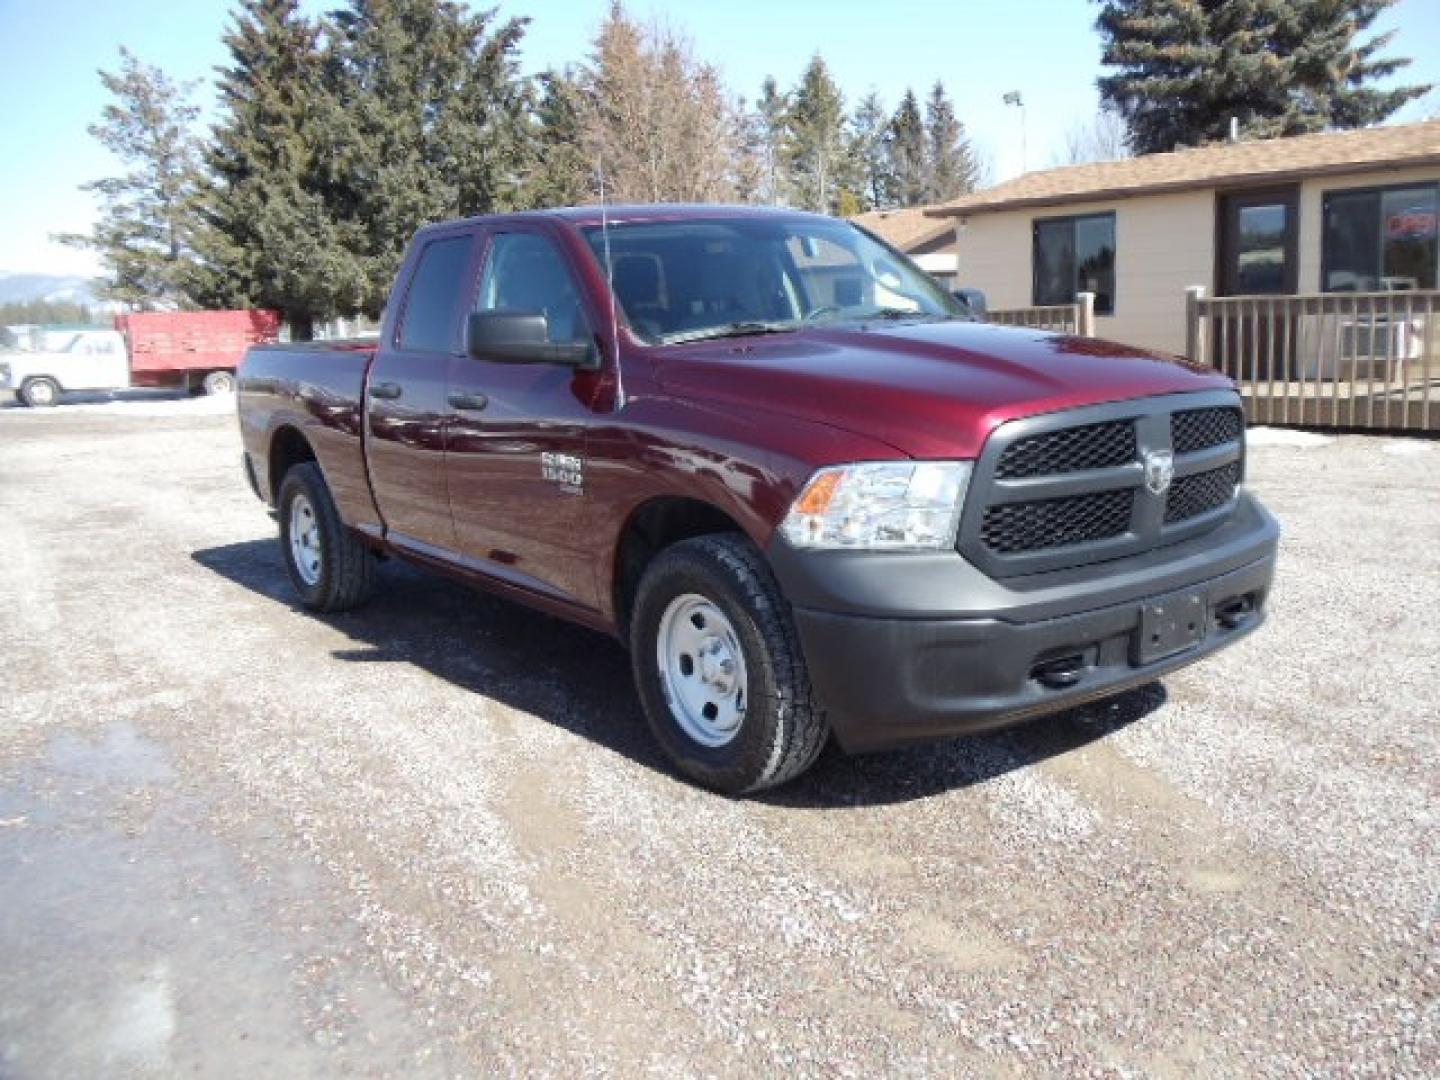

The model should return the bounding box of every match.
[585,217,968,344]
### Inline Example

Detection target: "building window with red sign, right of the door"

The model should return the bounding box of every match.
[1320,184,1440,292]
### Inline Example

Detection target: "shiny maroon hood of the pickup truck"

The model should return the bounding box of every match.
[657,323,1233,458]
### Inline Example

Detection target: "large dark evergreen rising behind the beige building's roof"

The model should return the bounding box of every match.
[1096,0,1428,153]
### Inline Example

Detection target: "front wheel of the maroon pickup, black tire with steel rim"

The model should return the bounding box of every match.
[631,534,829,793]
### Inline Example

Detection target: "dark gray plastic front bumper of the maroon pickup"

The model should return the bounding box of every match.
[770,495,1279,752]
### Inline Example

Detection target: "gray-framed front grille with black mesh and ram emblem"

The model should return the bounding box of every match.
[958,392,1244,577]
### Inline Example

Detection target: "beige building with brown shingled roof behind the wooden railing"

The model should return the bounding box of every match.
[887,121,1440,353]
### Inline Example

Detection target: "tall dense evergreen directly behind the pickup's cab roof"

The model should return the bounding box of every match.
[325,0,530,315]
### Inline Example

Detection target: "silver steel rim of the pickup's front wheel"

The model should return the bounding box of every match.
[655,593,749,747]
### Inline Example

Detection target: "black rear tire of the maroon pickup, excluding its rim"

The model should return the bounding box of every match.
[279,461,374,612]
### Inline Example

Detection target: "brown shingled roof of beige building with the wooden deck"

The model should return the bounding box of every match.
[926,120,1440,220]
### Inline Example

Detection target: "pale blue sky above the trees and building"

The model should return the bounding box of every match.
[0,0,1440,274]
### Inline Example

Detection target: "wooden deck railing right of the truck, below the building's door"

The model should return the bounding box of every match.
[1185,287,1440,431]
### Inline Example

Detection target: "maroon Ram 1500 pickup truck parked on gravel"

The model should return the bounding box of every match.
[239,206,1279,792]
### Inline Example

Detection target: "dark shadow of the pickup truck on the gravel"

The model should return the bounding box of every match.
[192,540,1165,806]
